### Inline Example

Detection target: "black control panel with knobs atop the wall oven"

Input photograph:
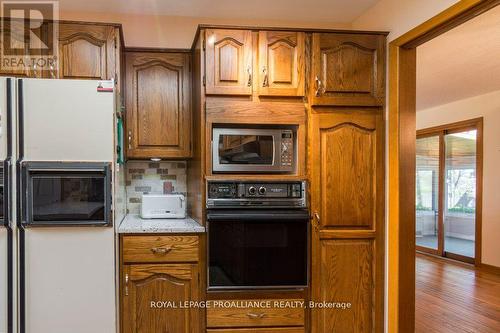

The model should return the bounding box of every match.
[207,181,306,207]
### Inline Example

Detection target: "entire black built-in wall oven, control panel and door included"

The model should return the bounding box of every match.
[207,182,309,290]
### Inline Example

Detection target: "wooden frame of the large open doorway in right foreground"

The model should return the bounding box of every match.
[387,0,500,333]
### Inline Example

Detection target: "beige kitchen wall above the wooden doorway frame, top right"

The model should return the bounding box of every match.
[352,0,458,41]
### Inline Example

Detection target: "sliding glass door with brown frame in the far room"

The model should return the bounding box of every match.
[415,119,482,263]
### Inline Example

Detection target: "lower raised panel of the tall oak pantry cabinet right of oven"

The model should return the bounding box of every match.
[311,239,376,333]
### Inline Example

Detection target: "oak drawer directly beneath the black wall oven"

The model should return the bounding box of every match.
[207,299,304,326]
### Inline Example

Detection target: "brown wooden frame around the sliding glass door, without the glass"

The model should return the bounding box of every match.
[415,117,483,266]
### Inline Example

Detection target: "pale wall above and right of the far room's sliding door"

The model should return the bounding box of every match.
[417,91,500,267]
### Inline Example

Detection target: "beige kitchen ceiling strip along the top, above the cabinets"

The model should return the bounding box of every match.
[59,0,378,23]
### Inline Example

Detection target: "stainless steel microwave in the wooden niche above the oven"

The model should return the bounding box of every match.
[212,127,297,173]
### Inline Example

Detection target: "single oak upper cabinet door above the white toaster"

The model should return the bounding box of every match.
[125,52,191,159]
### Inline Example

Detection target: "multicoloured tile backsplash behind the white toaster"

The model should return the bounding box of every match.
[126,161,187,214]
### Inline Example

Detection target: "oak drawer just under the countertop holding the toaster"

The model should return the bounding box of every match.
[122,236,199,263]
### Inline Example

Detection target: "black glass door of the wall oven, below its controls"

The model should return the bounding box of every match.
[208,210,308,289]
